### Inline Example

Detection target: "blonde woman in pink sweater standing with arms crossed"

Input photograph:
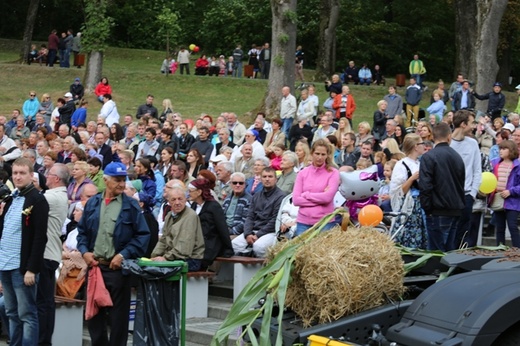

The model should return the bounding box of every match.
[293,139,339,236]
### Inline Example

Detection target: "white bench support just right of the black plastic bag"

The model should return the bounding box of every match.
[186,272,215,318]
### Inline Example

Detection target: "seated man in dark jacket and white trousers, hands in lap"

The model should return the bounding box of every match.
[232,167,285,258]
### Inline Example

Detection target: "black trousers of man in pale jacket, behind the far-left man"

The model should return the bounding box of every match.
[36,259,59,345]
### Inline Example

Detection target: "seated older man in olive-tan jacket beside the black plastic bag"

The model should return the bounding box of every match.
[151,184,204,271]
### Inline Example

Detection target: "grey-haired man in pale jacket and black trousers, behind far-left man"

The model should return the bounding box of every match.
[36,163,70,345]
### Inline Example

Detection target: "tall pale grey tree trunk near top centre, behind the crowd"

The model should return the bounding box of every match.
[260,0,297,117]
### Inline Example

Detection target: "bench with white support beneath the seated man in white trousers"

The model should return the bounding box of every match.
[215,256,265,301]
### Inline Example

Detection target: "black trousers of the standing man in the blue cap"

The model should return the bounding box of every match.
[88,264,130,346]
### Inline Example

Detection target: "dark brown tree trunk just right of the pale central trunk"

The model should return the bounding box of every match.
[314,0,339,81]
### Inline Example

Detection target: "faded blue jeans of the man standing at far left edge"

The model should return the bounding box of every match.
[0,269,39,346]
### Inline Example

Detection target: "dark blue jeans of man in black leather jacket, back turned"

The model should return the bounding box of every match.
[426,215,459,251]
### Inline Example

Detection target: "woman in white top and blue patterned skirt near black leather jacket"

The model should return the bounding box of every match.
[390,133,428,249]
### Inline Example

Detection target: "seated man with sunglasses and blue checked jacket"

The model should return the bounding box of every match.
[222,172,251,238]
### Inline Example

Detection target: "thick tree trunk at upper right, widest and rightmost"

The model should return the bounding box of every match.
[455,0,507,111]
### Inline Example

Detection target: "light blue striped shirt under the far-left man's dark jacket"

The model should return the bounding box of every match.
[0,196,25,270]
